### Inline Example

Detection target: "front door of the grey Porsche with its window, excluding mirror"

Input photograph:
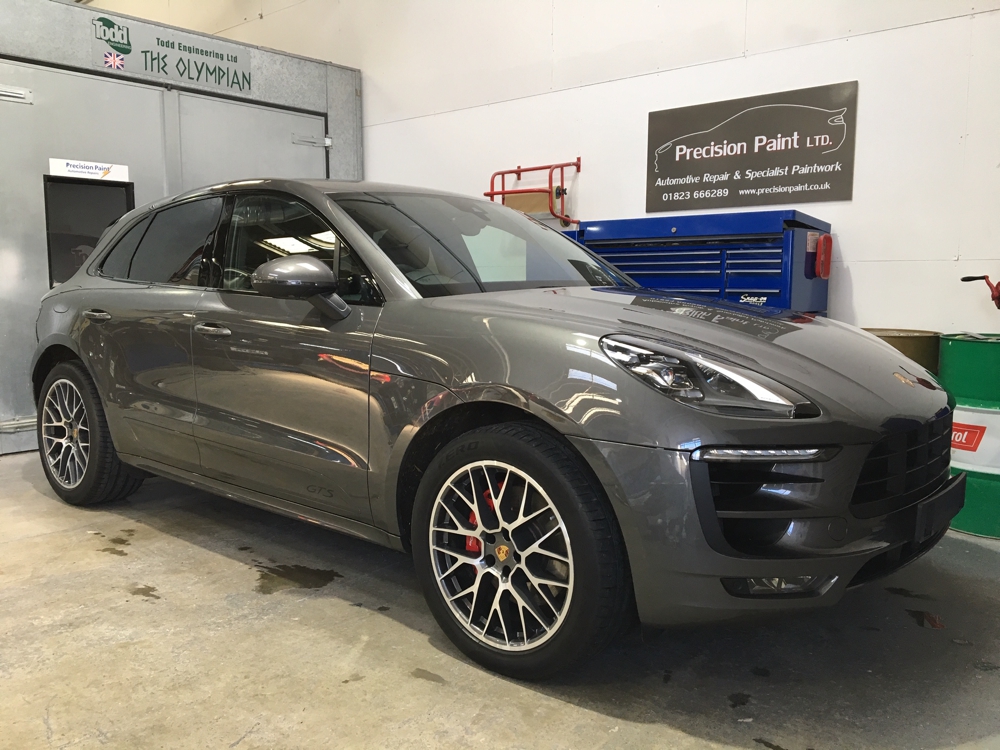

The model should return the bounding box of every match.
[194,194,381,522]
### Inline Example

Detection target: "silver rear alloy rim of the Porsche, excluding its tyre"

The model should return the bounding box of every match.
[42,378,90,489]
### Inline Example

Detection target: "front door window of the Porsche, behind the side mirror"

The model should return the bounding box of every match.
[222,195,375,304]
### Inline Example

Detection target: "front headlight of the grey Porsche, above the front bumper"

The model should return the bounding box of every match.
[601,335,820,419]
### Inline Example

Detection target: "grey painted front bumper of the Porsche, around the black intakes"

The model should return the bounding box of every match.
[573,438,965,626]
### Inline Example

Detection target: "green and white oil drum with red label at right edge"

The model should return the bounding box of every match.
[939,333,1000,538]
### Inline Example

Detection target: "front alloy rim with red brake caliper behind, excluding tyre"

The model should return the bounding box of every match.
[430,461,574,651]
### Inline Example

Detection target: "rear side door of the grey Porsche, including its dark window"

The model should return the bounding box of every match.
[80,197,224,471]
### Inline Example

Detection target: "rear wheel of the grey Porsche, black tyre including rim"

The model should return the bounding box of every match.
[37,362,146,505]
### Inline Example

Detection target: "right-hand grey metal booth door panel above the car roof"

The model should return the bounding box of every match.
[179,93,326,190]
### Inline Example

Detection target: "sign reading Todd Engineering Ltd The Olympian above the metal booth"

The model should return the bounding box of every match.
[91,16,253,94]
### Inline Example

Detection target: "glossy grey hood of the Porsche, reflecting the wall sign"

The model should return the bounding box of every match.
[380,287,947,426]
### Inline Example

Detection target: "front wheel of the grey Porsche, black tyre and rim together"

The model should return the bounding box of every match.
[411,422,634,680]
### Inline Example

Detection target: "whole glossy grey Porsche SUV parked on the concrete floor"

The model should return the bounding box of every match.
[32,180,965,678]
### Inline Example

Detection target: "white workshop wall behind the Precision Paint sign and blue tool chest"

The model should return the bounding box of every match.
[91,0,1000,331]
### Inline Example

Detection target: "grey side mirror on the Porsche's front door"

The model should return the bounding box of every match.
[250,255,351,320]
